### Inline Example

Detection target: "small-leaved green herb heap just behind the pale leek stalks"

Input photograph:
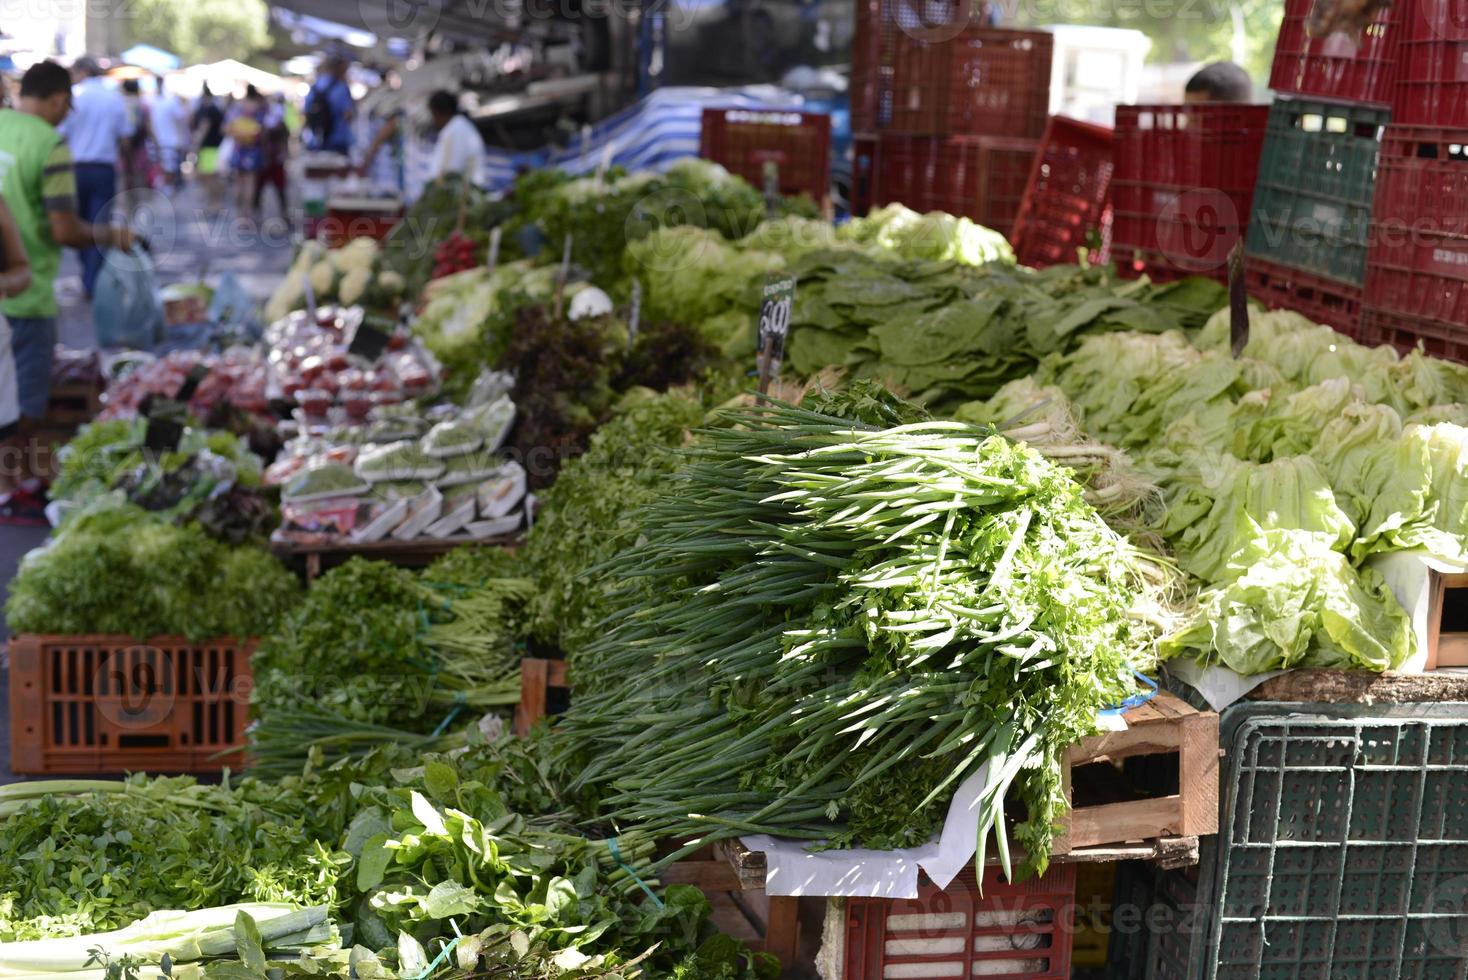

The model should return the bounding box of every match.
[0,776,348,942]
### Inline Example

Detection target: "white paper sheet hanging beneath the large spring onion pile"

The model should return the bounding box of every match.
[740,763,989,898]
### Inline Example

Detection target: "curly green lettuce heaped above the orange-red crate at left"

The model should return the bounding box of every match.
[4,505,299,640]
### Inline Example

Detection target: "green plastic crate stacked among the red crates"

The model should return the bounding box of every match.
[1246,97,1392,286]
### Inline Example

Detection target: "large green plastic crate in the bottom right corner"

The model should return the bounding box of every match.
[1209,704,1468,980]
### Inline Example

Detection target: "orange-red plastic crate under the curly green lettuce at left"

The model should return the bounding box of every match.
[7,635,255,775]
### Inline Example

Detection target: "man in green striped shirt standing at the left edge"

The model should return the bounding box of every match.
[0,62,132,420]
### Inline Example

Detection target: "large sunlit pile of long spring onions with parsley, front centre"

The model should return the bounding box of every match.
[562,393,1167,869]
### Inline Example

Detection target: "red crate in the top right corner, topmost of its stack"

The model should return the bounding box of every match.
[1392,0,1468,128]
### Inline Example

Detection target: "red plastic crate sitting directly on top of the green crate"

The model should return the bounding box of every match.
[1270,0,1397,104]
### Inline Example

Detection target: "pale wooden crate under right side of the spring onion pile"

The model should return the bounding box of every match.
[1053,691,1218,854]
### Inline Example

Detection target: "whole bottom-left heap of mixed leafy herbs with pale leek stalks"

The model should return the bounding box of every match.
[0,745,778,980]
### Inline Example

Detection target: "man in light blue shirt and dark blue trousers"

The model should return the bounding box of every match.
[57,57,132,299]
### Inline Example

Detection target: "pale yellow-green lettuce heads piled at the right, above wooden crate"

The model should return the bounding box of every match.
[960,311,1468,673]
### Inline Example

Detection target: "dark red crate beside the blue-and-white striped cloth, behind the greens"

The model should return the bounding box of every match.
[699,109,831,201]
